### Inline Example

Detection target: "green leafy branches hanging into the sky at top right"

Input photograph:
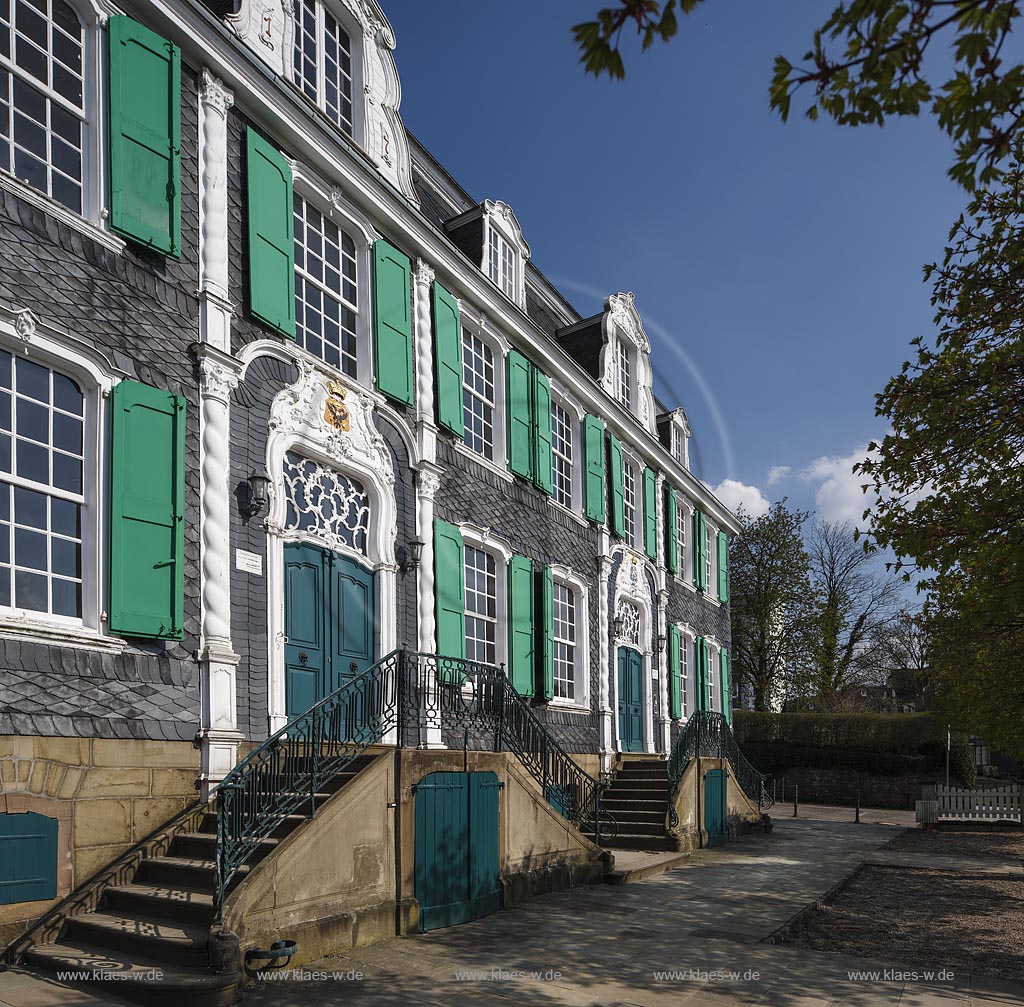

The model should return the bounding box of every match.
[572,0,1024,190]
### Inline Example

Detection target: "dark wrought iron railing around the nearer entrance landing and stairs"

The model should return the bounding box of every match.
[215,651,615,922]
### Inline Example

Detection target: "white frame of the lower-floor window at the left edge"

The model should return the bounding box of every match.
[0,310,118,651]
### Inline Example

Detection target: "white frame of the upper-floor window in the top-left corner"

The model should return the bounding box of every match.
[0,0,112,241]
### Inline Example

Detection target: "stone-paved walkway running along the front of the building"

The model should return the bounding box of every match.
[0,819,1024,1007]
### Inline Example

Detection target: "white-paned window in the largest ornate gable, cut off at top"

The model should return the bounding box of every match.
[292,0,355,136]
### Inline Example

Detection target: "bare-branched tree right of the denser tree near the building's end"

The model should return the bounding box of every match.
[796,521,900,709]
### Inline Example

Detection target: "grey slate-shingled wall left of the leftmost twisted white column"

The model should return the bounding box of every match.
[0,66,200,740]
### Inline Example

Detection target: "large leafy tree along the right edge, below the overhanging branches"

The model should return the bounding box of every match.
[858,160,1024,756]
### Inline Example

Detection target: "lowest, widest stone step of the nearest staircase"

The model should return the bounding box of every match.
[25,939,240,1007]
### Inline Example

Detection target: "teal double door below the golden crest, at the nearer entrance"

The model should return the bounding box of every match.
[285,542,376,729]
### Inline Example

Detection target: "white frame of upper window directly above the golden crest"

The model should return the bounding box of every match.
[290,169,376,393]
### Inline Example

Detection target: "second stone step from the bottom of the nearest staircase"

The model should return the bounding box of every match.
[68,910,210,968]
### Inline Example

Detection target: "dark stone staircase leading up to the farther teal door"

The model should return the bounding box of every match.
[601,759,676,852]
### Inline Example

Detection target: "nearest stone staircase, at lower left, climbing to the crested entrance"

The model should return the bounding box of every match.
[23,755,377,1007]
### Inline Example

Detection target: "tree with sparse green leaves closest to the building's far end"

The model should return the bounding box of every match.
[729,500,810,710]
